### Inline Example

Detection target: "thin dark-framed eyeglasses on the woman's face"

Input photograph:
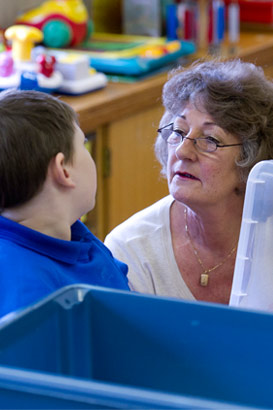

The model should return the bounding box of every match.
[157,122,243,152]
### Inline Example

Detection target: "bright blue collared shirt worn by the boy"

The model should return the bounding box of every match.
[0,216,129,316]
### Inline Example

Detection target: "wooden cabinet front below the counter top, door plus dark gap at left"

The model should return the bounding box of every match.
[79,103,168,239]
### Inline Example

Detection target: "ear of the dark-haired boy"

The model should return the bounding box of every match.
[49,152,75,188]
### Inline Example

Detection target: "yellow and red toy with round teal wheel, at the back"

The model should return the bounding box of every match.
[16,0,92,48]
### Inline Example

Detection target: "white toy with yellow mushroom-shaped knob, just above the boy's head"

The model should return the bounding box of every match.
[0,25,107,95]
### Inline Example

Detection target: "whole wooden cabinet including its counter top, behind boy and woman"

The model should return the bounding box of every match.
[63,33,273,240]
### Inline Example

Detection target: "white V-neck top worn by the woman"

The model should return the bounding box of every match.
[105,195,195,300]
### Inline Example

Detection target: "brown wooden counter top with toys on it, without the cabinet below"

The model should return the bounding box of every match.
[62,32,273,133]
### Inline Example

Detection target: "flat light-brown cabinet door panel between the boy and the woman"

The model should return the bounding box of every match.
[103,104,168,234]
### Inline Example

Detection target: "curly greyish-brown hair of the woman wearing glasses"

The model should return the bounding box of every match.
[155,59,273,181]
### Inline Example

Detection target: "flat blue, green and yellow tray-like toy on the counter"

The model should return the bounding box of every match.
[54,33,196,76]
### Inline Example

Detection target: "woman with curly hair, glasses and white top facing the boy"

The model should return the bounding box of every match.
[105,60,273,304]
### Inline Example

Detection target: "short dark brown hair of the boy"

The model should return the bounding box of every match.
[0,90,78,209]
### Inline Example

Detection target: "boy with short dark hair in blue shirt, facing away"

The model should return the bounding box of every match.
[0,90,129,316]
